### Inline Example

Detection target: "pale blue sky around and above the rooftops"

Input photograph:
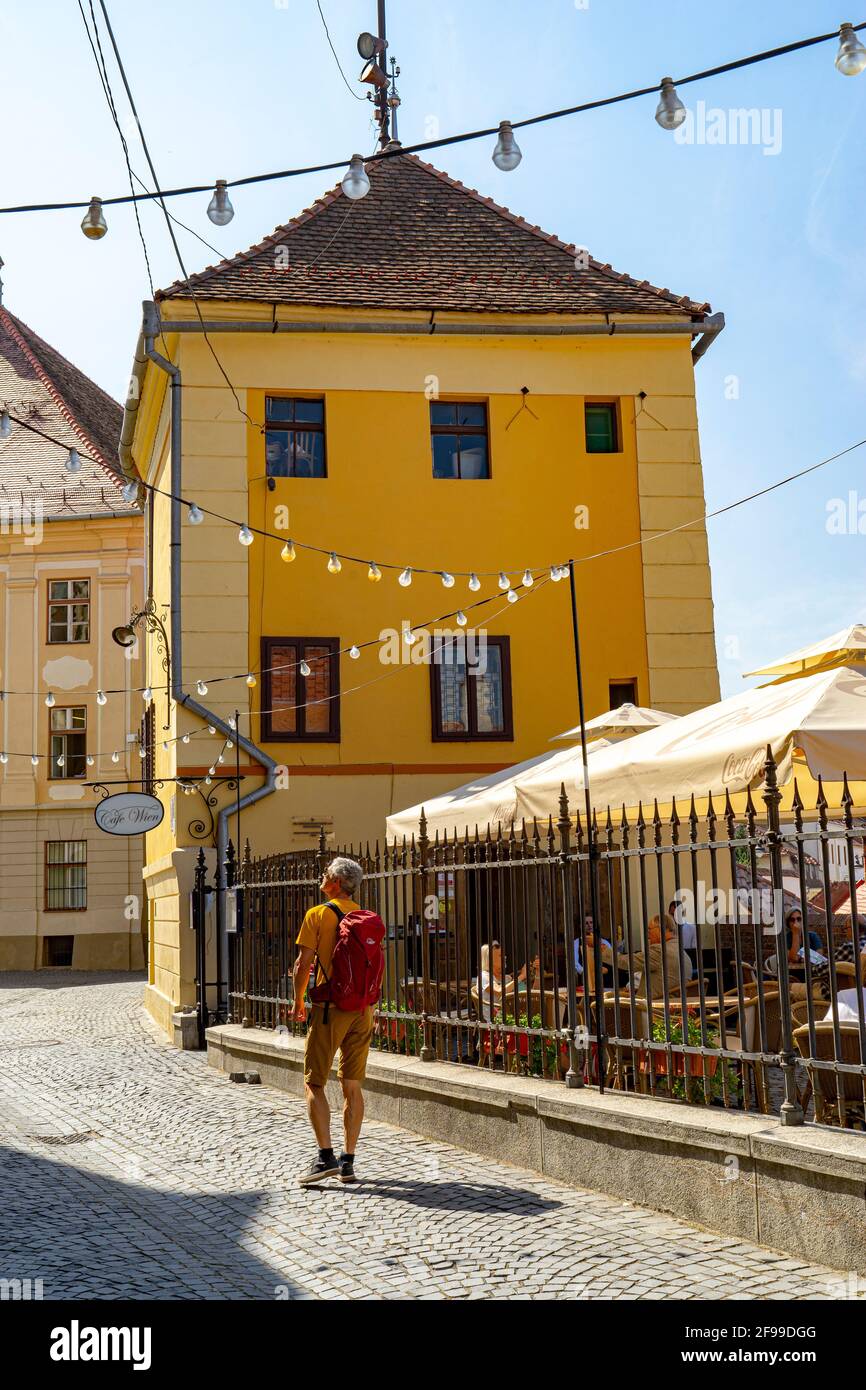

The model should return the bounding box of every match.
[0,0,866,694]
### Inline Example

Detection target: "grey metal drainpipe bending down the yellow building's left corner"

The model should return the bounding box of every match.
[139,300,278,1019]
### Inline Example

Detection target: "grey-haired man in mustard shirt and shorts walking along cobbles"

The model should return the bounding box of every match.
[292,856,384,1187]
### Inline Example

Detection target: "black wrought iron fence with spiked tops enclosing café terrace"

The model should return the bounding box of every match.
[209,756,866,1127]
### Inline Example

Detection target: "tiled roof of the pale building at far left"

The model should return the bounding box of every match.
[0,307,136,517]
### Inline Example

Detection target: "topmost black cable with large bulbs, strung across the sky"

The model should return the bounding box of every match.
[0,20,866,214]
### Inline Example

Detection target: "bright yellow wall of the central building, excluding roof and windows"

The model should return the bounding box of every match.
[133,304,719,1028]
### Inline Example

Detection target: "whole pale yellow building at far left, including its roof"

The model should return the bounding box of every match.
[0,309,145,970]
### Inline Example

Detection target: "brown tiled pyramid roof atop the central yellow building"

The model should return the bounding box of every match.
[157,154,710,318]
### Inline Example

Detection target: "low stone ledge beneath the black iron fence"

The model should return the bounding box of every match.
[207,1024,866,1275]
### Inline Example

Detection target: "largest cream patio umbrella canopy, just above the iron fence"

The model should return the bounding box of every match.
[388,669,866,838]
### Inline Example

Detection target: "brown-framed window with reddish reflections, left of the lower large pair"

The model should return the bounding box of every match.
[261,637,339,744]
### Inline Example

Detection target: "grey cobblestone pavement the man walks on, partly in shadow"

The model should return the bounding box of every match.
[0,972,856,1300]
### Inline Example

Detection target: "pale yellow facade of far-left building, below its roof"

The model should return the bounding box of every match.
[0,517,145,969]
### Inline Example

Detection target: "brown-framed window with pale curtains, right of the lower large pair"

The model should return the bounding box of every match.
[430,637,514,741]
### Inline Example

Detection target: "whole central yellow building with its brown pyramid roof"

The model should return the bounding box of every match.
[121,157,723,1026]
